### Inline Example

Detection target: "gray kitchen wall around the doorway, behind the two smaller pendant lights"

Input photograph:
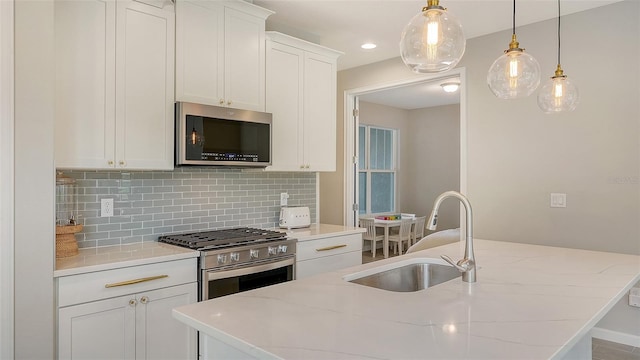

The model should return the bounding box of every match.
[320,1,640,336]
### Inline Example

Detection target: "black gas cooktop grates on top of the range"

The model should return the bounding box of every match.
[158,227,287,250]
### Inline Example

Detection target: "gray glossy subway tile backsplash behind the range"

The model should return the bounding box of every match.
[62,168,317,248]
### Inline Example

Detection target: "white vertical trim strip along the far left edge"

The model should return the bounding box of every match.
[0,1,14,359]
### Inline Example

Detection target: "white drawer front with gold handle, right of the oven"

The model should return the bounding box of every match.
[296,233,362,261]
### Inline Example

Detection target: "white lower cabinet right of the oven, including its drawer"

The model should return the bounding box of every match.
[296,233,362,279]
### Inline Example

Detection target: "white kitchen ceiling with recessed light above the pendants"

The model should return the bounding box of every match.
[253,0,621,108]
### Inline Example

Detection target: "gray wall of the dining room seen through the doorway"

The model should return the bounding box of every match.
[359,101,460,233]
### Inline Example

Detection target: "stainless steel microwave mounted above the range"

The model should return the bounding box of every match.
[175,102,272,167]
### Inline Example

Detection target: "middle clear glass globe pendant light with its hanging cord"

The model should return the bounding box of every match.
[487,0,540,99]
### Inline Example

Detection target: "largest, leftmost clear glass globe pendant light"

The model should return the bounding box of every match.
[400,0,466,73]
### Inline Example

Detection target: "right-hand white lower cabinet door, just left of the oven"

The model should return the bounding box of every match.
[136,283,198,360]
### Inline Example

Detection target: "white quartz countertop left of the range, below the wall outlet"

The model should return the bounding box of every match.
[53,241,200,277]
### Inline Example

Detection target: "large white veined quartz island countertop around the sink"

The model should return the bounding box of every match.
[173,239,640,359]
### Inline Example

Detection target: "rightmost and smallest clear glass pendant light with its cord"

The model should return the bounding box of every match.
[538,0,578,114]
